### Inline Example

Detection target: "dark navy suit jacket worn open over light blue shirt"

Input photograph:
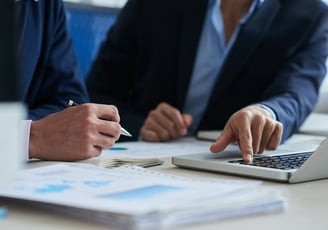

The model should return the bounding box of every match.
[87,0,328,140]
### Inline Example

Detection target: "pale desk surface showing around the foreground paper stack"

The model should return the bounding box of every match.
[0,156,328,230]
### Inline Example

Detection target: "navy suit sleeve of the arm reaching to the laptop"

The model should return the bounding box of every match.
[261,11,328,141]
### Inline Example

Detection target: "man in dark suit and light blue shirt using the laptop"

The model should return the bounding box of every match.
[87,0,328,161]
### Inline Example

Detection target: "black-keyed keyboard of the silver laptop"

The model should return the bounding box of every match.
[229,152,312,170]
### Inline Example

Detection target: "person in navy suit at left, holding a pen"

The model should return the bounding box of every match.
[13,0,120,161]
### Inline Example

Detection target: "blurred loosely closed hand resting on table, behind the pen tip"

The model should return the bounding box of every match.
[141,103,192,142]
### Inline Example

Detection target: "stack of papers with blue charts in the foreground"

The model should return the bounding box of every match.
[0,164,285,230]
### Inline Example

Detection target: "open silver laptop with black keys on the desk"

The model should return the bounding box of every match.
[172,133,328,183]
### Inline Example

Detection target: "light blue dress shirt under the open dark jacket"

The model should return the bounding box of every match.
[183,0,265,135]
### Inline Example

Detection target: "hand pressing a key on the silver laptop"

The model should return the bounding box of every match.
[210,105,283,162]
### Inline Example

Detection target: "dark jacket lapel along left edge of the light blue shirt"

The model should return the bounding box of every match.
[176,0,208,109]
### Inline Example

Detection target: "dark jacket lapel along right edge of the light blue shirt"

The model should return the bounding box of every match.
[211,0,280,101]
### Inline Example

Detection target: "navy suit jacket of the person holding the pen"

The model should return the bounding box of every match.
[15,0,89,120]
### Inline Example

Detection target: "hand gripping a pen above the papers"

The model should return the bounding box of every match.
[29,103,121,161]
